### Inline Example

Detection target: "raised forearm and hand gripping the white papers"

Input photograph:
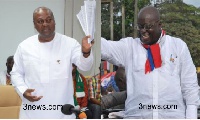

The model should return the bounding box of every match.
[71,36,93,71]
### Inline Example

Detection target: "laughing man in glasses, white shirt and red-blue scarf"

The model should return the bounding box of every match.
[101,6,199,119]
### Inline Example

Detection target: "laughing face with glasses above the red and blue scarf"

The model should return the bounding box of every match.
[138,17,161,45]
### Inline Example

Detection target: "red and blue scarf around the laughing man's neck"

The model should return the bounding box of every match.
[143,30,165,74]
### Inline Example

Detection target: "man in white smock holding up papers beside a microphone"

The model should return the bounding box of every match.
[11,7,93,119]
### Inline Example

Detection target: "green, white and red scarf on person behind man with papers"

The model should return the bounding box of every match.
[74,70,85,106]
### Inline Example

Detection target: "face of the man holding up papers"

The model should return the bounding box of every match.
[34,9,55,39]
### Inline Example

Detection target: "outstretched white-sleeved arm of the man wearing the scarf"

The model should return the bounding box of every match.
[101,38,127,66]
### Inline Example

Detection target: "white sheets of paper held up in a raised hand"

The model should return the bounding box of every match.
[77,0,96,43]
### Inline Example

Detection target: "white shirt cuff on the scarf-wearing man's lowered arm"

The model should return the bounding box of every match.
[186,105,197,119]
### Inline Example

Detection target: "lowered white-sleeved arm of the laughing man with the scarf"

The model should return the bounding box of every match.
[181,42,199,119]
